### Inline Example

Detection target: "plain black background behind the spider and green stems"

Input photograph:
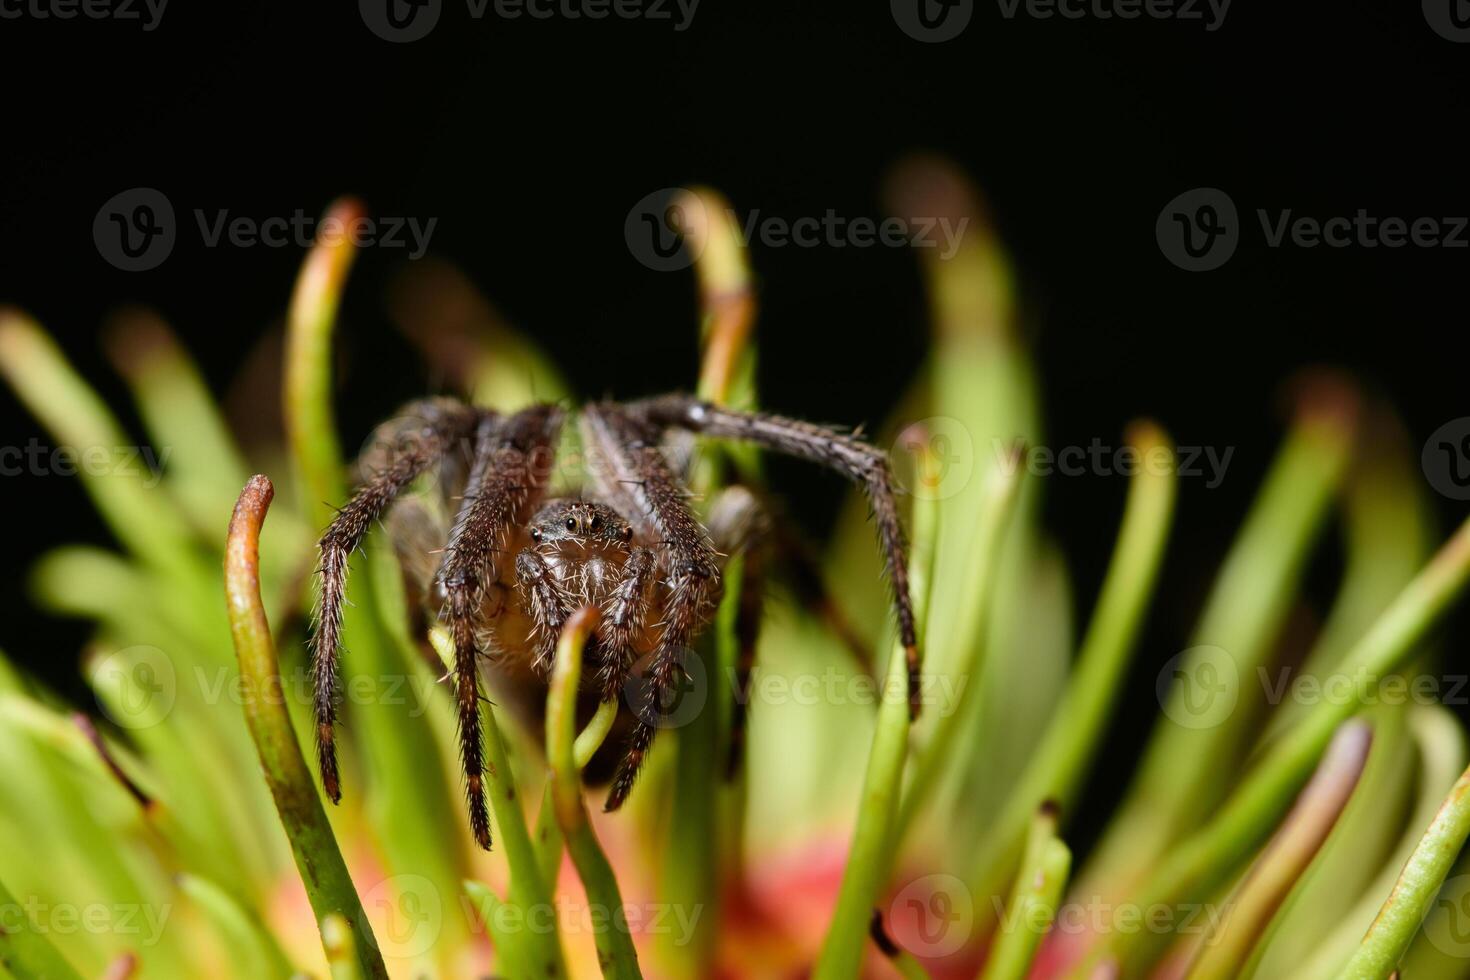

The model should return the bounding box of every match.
[0,0,1470,846]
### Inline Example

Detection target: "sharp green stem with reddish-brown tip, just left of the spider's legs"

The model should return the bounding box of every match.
[225,476,388,979]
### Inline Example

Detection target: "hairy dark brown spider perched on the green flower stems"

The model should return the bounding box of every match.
[310,394,919,849]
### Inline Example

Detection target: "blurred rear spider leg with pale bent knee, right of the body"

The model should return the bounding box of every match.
[710,486,772,779]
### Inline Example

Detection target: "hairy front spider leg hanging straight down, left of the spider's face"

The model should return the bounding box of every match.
[440,406,562,851]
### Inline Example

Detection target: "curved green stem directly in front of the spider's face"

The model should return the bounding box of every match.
[547,607,642,980]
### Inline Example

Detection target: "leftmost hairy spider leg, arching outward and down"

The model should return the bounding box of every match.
[312,398,481,802]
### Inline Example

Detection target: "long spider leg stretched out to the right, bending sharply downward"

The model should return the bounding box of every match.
[626,395,919,714]
